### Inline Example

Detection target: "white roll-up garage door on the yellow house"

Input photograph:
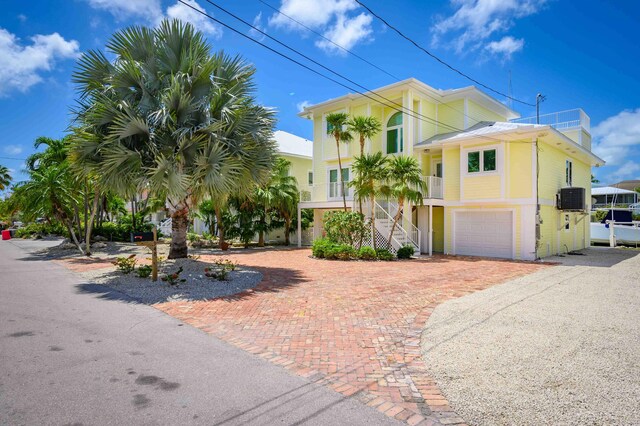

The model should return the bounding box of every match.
[453,211,513,258]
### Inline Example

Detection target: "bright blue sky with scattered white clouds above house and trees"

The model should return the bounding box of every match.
[0,0,640,187]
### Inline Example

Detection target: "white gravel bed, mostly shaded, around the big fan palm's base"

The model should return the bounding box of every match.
[82,255,262,304]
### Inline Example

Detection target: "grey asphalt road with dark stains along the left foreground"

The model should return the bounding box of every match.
[0,240,397,425]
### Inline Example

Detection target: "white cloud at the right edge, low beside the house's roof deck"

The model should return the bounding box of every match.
[591,108,640,170]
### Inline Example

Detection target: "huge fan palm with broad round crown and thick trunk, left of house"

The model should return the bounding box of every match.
[72,20,275,258]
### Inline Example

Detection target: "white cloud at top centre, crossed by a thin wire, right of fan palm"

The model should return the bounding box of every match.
[269,0,373,53]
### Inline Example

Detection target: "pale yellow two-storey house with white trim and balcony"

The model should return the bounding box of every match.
[299,78,604,259]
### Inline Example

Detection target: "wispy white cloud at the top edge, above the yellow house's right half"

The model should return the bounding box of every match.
[432,0,547,53]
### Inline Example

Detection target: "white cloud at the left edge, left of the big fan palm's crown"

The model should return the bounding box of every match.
[0,28,80,97]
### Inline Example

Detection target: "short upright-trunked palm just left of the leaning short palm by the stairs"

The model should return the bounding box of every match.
[352,152,389,249]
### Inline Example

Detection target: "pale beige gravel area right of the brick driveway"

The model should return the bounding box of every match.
[422,248,640,425]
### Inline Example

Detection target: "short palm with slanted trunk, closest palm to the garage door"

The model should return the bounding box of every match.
[382,155,426,246]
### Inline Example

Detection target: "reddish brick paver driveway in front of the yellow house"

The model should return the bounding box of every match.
[155,249,544,424]
